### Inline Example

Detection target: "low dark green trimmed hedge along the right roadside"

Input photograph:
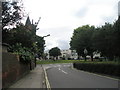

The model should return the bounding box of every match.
[73,63,120,77]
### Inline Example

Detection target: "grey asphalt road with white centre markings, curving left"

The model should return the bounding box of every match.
[43,64,118,90]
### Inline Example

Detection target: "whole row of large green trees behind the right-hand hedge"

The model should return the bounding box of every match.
[70,17,120,61]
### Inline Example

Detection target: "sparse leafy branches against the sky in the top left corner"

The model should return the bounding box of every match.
[2,1,24,29]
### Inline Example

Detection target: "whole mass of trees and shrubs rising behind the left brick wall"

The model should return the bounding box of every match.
[2,2,45,62]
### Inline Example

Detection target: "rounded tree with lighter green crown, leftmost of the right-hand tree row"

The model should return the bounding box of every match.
[70,25,95,61]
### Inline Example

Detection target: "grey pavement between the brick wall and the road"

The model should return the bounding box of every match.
[9,65,46,89]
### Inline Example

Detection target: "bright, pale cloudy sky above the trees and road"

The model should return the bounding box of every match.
[23,0,119,50]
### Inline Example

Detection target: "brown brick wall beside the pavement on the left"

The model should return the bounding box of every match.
[2,52,30,88]
